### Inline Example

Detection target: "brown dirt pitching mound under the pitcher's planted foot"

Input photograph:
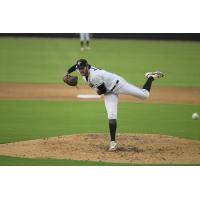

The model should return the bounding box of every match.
[0,134,200,164]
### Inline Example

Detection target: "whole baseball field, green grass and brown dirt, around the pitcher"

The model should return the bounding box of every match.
[0,37,200,166]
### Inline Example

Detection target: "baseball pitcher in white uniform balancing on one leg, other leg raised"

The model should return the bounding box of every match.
[64,59,164,151]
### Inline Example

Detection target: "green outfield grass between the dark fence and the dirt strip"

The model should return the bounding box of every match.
[0,37,200,87]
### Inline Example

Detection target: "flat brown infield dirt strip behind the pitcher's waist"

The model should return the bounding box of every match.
[0,83,200,105]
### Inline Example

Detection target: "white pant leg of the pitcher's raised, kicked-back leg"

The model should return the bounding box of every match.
[119,82,149,99]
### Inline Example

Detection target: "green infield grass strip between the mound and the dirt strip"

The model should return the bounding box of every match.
[0,101,200,143]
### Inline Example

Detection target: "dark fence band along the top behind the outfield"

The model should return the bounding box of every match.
[0,33,200,41]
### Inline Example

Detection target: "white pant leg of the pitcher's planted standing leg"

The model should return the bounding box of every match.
[104,93,118,119]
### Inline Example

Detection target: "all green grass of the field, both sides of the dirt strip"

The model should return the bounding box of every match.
[0,37,200,165]
